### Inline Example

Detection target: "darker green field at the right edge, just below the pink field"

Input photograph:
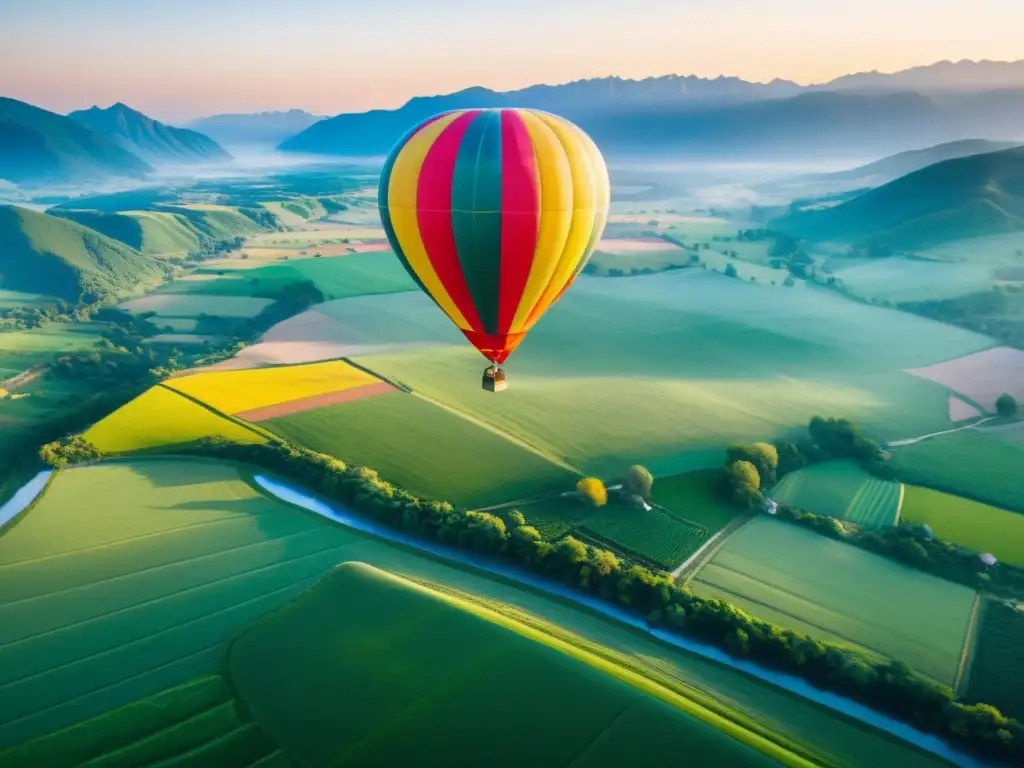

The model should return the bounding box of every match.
[892,429,1024,512]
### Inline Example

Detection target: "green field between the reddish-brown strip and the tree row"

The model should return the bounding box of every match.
[261,392,575,507]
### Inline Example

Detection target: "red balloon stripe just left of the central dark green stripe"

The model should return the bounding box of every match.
[416,110,483,331]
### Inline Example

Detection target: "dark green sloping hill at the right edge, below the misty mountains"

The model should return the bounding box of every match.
[773,147,1024,248]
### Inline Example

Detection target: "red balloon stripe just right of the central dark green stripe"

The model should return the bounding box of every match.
[498,110,541,334]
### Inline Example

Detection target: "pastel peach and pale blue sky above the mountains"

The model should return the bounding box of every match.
[0,0,1024,121]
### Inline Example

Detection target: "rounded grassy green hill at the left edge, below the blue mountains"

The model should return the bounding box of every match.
[0,206,163,303]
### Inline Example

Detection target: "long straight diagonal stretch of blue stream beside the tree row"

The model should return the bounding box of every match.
[254,475,989,768]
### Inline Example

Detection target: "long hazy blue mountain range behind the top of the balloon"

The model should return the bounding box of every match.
[280,81,1024,159]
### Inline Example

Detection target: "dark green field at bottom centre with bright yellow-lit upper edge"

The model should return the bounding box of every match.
[228,564,798,768]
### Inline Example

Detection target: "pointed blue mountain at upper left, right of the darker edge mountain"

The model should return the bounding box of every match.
[68,101,230,163]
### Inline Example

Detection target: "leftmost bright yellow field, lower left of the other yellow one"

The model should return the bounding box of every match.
[85,385,266,454]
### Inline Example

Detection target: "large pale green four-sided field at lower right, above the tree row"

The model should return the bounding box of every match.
[692,517,975,685]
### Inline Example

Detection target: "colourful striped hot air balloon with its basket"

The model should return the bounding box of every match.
[378,110,610,391]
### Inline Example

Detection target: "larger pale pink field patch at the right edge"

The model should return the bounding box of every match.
[907,347,1024,411]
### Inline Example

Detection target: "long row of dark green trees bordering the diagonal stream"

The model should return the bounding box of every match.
[39,438,1024,764]
